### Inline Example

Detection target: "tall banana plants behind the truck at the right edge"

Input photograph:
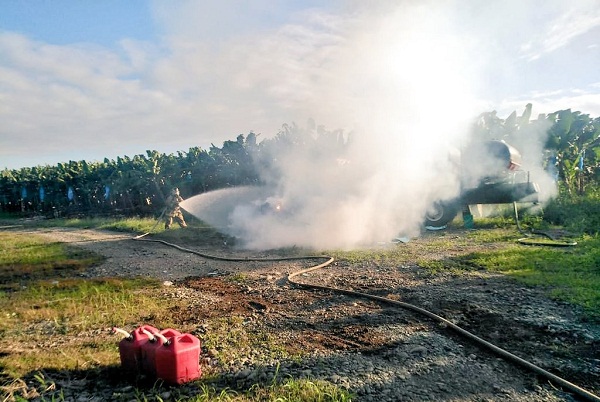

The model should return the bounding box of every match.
[473,104,600,234]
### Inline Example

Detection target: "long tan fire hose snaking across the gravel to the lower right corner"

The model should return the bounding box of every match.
[133,233,600,402]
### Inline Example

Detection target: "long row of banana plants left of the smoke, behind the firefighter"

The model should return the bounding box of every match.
[0,133,259,216]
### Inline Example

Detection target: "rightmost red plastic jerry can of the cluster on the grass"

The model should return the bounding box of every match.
[156,334,202,384]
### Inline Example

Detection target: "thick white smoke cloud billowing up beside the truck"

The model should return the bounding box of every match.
[183,2,556,248]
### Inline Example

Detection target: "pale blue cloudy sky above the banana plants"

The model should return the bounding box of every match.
[0,0,600,169]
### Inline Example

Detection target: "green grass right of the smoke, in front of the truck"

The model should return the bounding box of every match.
[330,217,600,320]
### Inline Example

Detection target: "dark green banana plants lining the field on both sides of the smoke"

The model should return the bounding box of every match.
[0,104,600,216]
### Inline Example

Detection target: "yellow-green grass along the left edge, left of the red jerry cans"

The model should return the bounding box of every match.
[0,232,175,377]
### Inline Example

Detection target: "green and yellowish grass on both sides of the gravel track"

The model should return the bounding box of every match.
[0,212,600,402]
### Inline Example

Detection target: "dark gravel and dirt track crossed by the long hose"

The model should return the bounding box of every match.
[5,229,600,402]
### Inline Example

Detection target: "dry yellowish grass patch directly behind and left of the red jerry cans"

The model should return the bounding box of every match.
[0,279,176,378]
